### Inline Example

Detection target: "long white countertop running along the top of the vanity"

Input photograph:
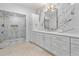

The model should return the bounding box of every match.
[33,30,79,38]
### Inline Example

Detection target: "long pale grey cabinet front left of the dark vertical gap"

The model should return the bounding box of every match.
[32,32,70,56]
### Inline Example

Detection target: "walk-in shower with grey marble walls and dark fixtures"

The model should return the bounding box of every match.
[0,10,26,48]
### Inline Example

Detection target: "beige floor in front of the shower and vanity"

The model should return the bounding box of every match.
[0,43,51,56]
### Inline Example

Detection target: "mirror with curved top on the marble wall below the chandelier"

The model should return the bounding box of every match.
[44,9,58,31]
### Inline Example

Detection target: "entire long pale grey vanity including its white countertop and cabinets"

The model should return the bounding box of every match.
[31,31,79,56]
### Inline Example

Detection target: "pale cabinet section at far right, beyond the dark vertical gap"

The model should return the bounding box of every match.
[71,38,79,56]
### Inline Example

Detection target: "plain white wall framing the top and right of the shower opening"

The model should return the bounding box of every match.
[0,3,35,41]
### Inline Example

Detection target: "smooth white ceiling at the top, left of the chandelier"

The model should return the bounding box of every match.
[18,3,45,10]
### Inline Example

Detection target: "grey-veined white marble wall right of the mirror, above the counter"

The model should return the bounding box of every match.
[37,3,79,34]
